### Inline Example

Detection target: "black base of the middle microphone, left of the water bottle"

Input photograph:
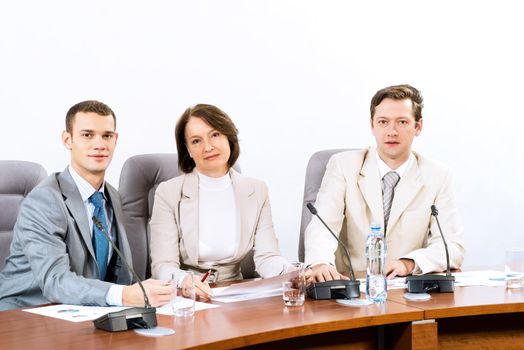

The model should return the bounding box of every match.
[307,280,360,300]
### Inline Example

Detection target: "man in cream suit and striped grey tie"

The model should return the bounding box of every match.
[305,85,464,282]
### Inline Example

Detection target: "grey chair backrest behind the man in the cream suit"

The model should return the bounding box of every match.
[298,149,349,261]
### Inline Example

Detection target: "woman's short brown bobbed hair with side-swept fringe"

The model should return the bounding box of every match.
[175,104,240,173]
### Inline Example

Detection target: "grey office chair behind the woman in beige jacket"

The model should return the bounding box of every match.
[118,153,255,279]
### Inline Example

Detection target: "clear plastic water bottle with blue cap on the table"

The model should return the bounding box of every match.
[366,223,388,303]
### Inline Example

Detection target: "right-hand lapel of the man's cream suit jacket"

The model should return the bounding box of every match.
[388,157,422,232]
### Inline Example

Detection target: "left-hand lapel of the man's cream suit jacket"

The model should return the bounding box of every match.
[358,151,384,227]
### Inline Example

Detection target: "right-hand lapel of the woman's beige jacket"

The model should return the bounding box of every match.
[230,169,258,258]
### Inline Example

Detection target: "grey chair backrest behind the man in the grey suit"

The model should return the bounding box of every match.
[0,160,47,270]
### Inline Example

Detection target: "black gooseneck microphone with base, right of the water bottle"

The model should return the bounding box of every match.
[406,205,455,293]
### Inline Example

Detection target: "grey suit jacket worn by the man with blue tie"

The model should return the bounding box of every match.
[0,169,132,310]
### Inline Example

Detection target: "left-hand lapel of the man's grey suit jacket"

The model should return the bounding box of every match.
[57,169,96,261]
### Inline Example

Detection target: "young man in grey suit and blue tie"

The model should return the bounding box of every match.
[0,101,172,310]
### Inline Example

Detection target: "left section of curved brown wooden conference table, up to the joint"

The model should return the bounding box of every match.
[0,297,423,350]
